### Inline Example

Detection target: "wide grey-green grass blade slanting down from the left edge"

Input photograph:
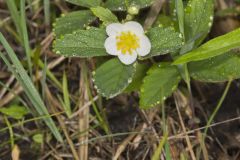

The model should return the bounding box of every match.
[0,33,63,142]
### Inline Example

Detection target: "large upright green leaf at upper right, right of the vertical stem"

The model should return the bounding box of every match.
[184,0,214,45]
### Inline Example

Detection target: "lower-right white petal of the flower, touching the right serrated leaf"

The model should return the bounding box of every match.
[137,35,151,56]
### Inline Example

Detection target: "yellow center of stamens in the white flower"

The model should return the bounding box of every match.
[116,31,140,55]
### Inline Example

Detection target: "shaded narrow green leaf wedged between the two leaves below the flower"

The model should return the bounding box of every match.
[125,63,149,92]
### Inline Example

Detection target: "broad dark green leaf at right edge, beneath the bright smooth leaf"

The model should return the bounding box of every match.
[188,51,240,82]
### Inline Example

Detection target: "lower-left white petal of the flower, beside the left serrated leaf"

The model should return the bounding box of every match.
[104,36,120,56]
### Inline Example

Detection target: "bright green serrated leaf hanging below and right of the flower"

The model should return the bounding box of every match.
[140,64,181,109]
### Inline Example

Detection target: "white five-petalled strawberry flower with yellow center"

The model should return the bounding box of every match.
[104,21,151,65]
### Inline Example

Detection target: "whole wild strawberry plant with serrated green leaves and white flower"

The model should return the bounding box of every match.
[54,0,240,109]
